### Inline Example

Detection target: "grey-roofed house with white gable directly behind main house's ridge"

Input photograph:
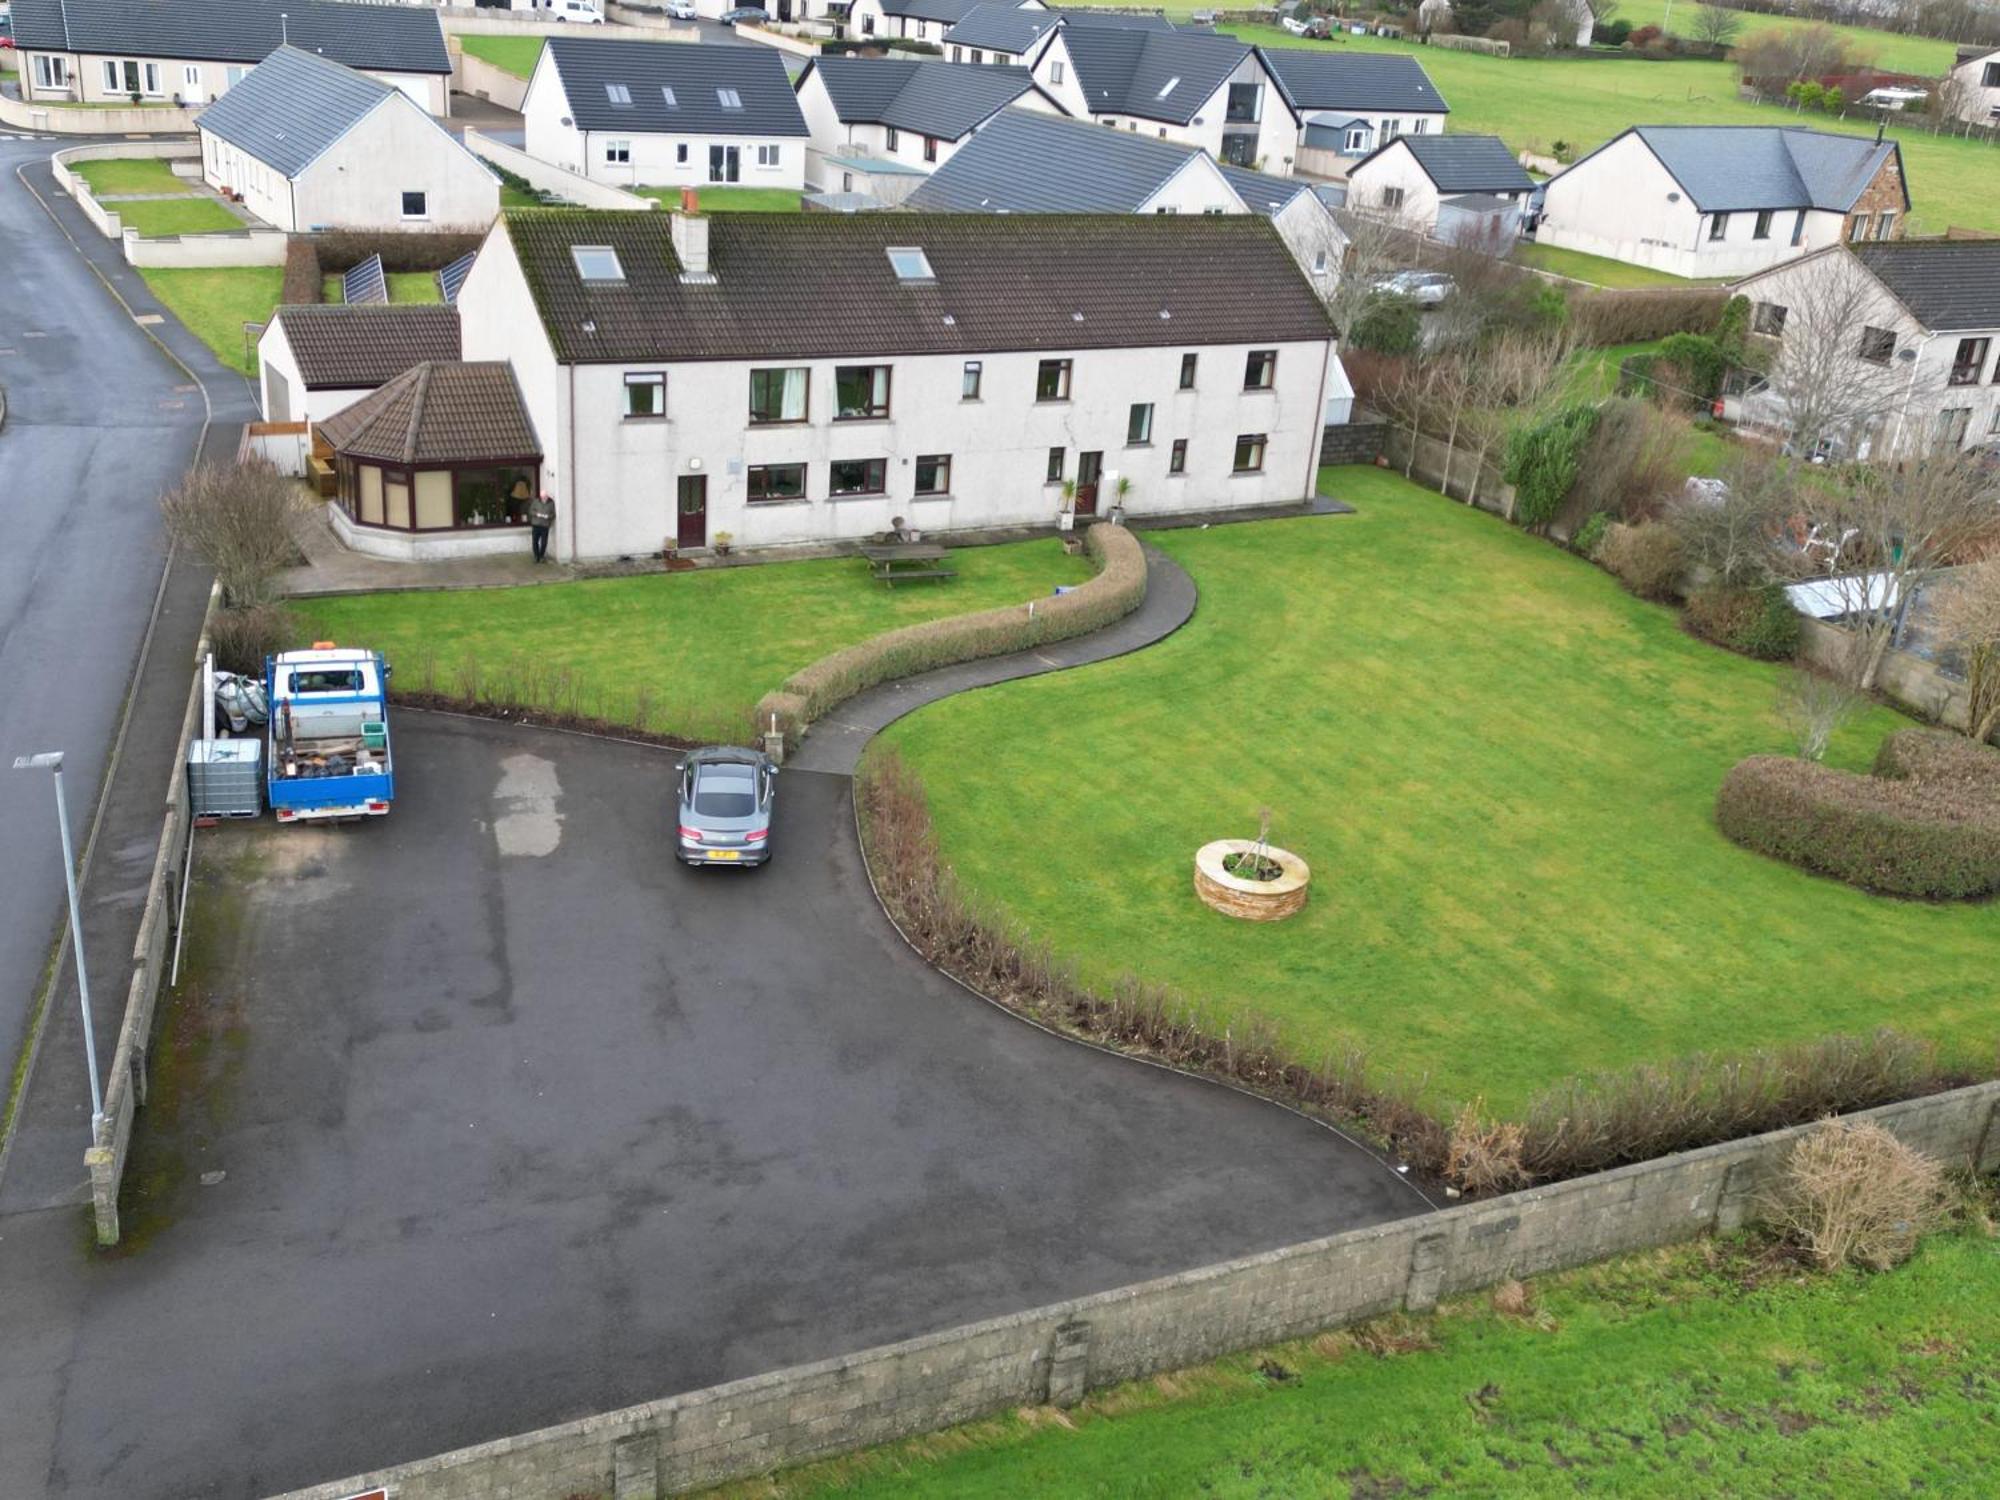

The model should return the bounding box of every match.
[906,110,1348,298]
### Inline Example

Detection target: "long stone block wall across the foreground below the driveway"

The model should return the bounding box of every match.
[284,1082,2000,1500]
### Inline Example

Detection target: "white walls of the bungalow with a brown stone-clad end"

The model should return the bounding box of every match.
[1536,136,1846,278]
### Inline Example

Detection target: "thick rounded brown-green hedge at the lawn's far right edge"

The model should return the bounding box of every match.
[1716,756,2000,900]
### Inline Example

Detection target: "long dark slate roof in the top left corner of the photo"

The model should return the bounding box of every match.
[14,0,452,72]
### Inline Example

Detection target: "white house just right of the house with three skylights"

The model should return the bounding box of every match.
[796,58,1062,204]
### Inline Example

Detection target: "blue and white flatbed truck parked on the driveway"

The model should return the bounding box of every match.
[264,642,396,822]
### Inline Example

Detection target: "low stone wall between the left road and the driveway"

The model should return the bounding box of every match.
[84,586,220,1246]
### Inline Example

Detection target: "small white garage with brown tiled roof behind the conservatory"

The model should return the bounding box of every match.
[256,302,458,422]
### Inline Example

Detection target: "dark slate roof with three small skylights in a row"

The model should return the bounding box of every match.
[546,36,812,136]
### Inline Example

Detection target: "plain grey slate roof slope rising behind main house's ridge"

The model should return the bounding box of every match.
[908,107,1202,214]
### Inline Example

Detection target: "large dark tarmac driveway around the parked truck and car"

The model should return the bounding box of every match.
[0,712,1424,1500]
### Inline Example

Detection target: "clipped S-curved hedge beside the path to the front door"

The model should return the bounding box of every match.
[756,524,1146,742]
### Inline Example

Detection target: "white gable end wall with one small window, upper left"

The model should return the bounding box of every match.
[288,96,500,230]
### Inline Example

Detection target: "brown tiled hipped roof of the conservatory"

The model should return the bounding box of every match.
[320,360,542,464]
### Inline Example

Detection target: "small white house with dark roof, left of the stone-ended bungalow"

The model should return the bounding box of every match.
[1348,136,1534,254]
